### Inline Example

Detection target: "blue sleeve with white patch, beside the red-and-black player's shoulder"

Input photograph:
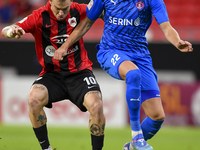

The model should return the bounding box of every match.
[86,0,103,21]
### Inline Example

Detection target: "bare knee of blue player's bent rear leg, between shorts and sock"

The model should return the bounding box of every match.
[142,97,165,120]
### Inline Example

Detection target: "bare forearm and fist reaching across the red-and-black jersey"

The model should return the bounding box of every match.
[54,17,94,61]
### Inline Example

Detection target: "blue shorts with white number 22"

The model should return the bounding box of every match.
[97,46,160,102]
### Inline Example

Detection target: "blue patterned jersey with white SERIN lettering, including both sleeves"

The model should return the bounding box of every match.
[87,0,169,56]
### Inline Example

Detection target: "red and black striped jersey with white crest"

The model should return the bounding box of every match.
[16,2,92,76]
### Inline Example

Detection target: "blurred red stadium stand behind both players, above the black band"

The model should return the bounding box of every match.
[0,0,200,42]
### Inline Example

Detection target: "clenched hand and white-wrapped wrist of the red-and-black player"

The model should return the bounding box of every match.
[1,24,25,39]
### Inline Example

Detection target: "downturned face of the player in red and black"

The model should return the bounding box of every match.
[50,0,72,21]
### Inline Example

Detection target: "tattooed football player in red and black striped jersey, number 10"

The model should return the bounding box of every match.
[2,0,105,150]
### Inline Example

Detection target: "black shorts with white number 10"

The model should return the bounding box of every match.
[33,69,101,112]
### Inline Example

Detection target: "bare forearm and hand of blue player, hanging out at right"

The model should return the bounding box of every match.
[160,21,193,52]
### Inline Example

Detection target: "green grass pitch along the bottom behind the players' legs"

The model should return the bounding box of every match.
[0,125,200,150]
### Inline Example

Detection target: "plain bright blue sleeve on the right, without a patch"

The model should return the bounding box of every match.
[150,0,169,24]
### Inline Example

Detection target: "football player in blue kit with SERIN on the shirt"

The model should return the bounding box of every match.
[54,0,193,150]
